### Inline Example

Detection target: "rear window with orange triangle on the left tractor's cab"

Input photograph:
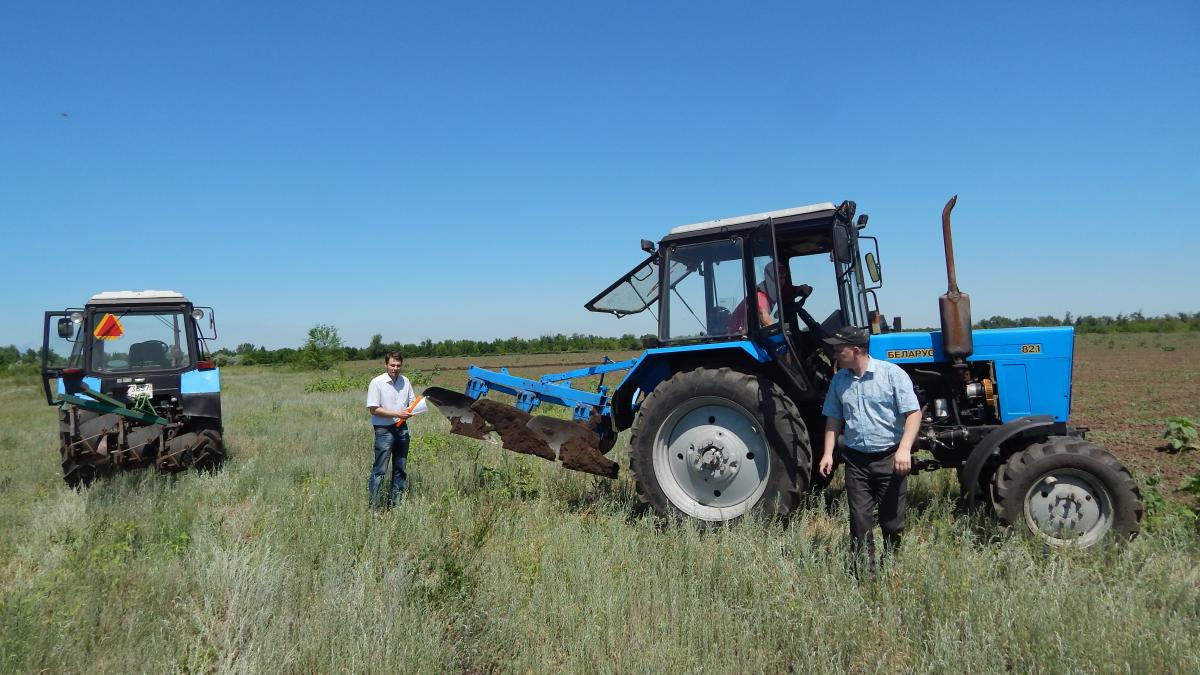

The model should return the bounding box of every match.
[90,310,192,374]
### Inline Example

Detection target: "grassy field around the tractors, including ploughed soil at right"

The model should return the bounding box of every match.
[0,335,1200,673]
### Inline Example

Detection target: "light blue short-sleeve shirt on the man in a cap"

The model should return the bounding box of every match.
[821,358,920,453]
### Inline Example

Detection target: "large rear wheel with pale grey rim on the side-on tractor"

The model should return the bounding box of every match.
[629,368,812,524]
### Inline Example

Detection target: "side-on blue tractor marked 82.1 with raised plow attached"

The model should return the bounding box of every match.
[426,199,1142,546]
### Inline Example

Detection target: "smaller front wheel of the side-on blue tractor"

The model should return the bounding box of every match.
[992,436,1145,548]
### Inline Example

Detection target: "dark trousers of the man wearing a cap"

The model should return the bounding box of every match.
[842,448,907,568]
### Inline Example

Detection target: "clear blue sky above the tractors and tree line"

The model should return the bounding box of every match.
[0,1,1200,348]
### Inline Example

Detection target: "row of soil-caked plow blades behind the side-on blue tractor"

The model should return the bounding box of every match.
[425,387,618,478]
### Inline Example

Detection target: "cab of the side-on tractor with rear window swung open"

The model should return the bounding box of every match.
[584,202,882,393]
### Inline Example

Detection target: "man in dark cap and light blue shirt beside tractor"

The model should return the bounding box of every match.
[817,327,920,569]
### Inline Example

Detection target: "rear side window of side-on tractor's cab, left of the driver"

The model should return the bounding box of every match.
[664,239,746,340]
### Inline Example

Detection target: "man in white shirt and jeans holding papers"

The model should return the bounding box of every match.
[367,352,416,508]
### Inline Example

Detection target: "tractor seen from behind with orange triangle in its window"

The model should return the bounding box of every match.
[42,291,226,488]
